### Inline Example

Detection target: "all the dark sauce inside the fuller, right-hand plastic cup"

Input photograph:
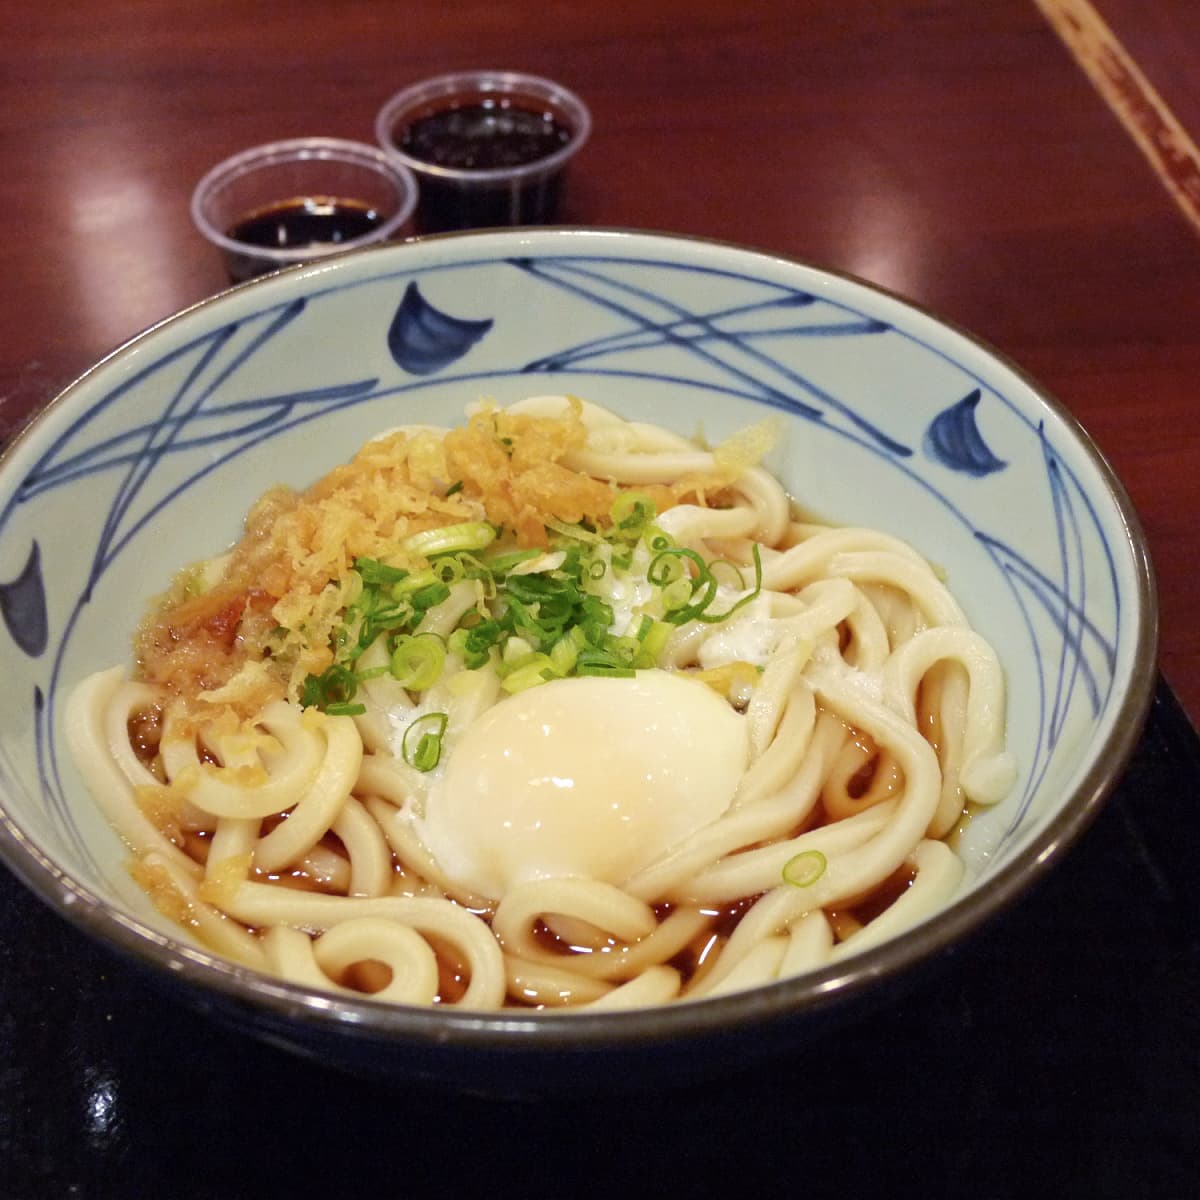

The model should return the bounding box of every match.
[392,96,575,233]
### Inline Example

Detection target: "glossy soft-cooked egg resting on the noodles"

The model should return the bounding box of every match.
[418,671,748,899]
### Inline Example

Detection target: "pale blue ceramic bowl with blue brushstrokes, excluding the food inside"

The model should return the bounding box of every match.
[0,229,1157,1092]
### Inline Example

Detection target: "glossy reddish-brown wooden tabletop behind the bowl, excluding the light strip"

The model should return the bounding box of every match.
[0,0,1200,720]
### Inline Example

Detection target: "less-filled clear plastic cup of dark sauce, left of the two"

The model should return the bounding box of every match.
[192,138,418,283]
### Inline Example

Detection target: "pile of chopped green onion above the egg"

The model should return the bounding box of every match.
[302,501,762,705]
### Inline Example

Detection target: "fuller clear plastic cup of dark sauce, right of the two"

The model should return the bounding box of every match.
[376,71,592,233]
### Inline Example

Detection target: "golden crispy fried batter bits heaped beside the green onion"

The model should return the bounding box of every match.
[134,401,737,715]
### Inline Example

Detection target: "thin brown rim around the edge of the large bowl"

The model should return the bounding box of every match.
[0,226,1159,1052]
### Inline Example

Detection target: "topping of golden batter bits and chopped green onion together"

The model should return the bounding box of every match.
[131,401,768,720]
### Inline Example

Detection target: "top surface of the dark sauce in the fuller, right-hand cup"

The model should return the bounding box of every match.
[396,100,571,170]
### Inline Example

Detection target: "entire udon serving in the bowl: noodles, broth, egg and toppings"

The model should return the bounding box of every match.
[67,397,1013,1009]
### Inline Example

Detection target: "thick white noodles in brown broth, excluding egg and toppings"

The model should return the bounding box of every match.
[66,396,1015,1010]
